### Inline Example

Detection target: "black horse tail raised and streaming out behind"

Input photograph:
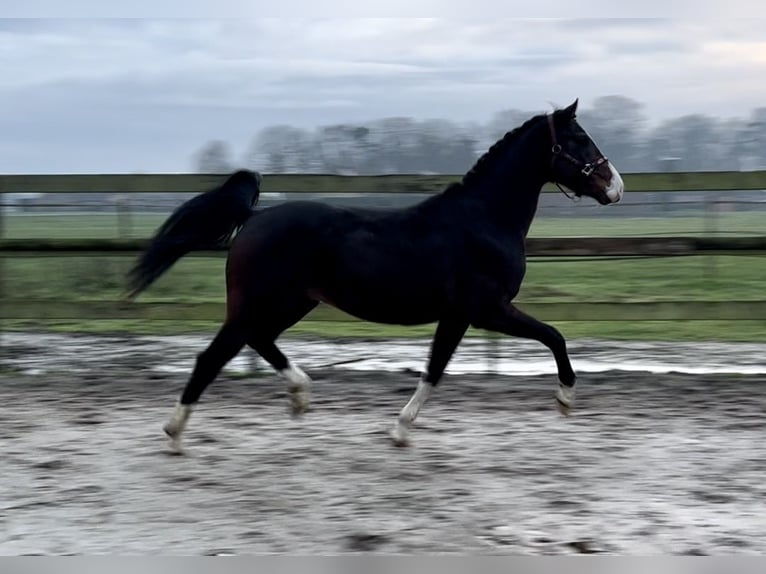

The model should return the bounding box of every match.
[128,170,261,298]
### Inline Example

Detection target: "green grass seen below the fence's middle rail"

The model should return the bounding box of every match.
[0,256,766,341]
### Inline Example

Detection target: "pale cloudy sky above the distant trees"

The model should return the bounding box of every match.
[0,17,766,173]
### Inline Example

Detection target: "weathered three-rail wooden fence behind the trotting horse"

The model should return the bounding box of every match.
[0,171,766,321]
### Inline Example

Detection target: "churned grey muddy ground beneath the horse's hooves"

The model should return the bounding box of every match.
[0,338,766,555]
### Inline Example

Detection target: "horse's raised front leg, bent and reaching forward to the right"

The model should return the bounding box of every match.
[471,304,577,415]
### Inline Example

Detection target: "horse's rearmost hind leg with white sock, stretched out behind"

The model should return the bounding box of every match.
[163,322,247,450]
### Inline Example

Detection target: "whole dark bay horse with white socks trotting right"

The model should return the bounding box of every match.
[132,101,623,448]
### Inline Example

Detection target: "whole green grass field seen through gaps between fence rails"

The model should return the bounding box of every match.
[0,209,766,341]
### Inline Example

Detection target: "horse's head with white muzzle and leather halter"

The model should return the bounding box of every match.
[548,100,624,205]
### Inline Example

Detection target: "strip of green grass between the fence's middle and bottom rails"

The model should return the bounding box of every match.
[3,255,766,303]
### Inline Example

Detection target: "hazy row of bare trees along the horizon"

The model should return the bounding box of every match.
[189,95,766,174]
